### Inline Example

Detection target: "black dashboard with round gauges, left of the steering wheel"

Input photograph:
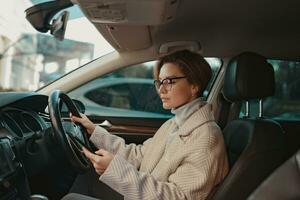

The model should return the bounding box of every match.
[0,92,51,199]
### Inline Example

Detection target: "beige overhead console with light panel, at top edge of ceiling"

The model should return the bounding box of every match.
[72,0,179,25]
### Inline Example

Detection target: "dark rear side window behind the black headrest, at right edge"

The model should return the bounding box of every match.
[240,60,300,120]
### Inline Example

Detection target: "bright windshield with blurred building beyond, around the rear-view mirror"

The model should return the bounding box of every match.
[0,0,114,91]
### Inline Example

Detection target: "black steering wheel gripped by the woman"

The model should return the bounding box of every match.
[48,90,90,173]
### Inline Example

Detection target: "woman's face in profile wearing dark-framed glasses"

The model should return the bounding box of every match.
[158,63,198,109]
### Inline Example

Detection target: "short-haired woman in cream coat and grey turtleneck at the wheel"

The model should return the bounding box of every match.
[63,50,228,200]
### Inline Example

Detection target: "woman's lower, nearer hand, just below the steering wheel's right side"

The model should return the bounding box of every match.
[83,147,114,175]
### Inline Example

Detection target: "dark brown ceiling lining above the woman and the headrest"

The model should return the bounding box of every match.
[80,0,300,59]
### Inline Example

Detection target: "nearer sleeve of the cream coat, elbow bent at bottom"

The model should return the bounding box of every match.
[100,127,227,200]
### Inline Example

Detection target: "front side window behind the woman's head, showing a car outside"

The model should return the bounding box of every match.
[69,58,221,118]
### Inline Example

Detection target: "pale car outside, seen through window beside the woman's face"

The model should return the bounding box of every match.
[69,77,172,118]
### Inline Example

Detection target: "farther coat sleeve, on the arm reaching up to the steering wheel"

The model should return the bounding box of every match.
[90,126,152,168]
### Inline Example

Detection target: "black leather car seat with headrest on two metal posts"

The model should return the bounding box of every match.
[209,52,286,200]
